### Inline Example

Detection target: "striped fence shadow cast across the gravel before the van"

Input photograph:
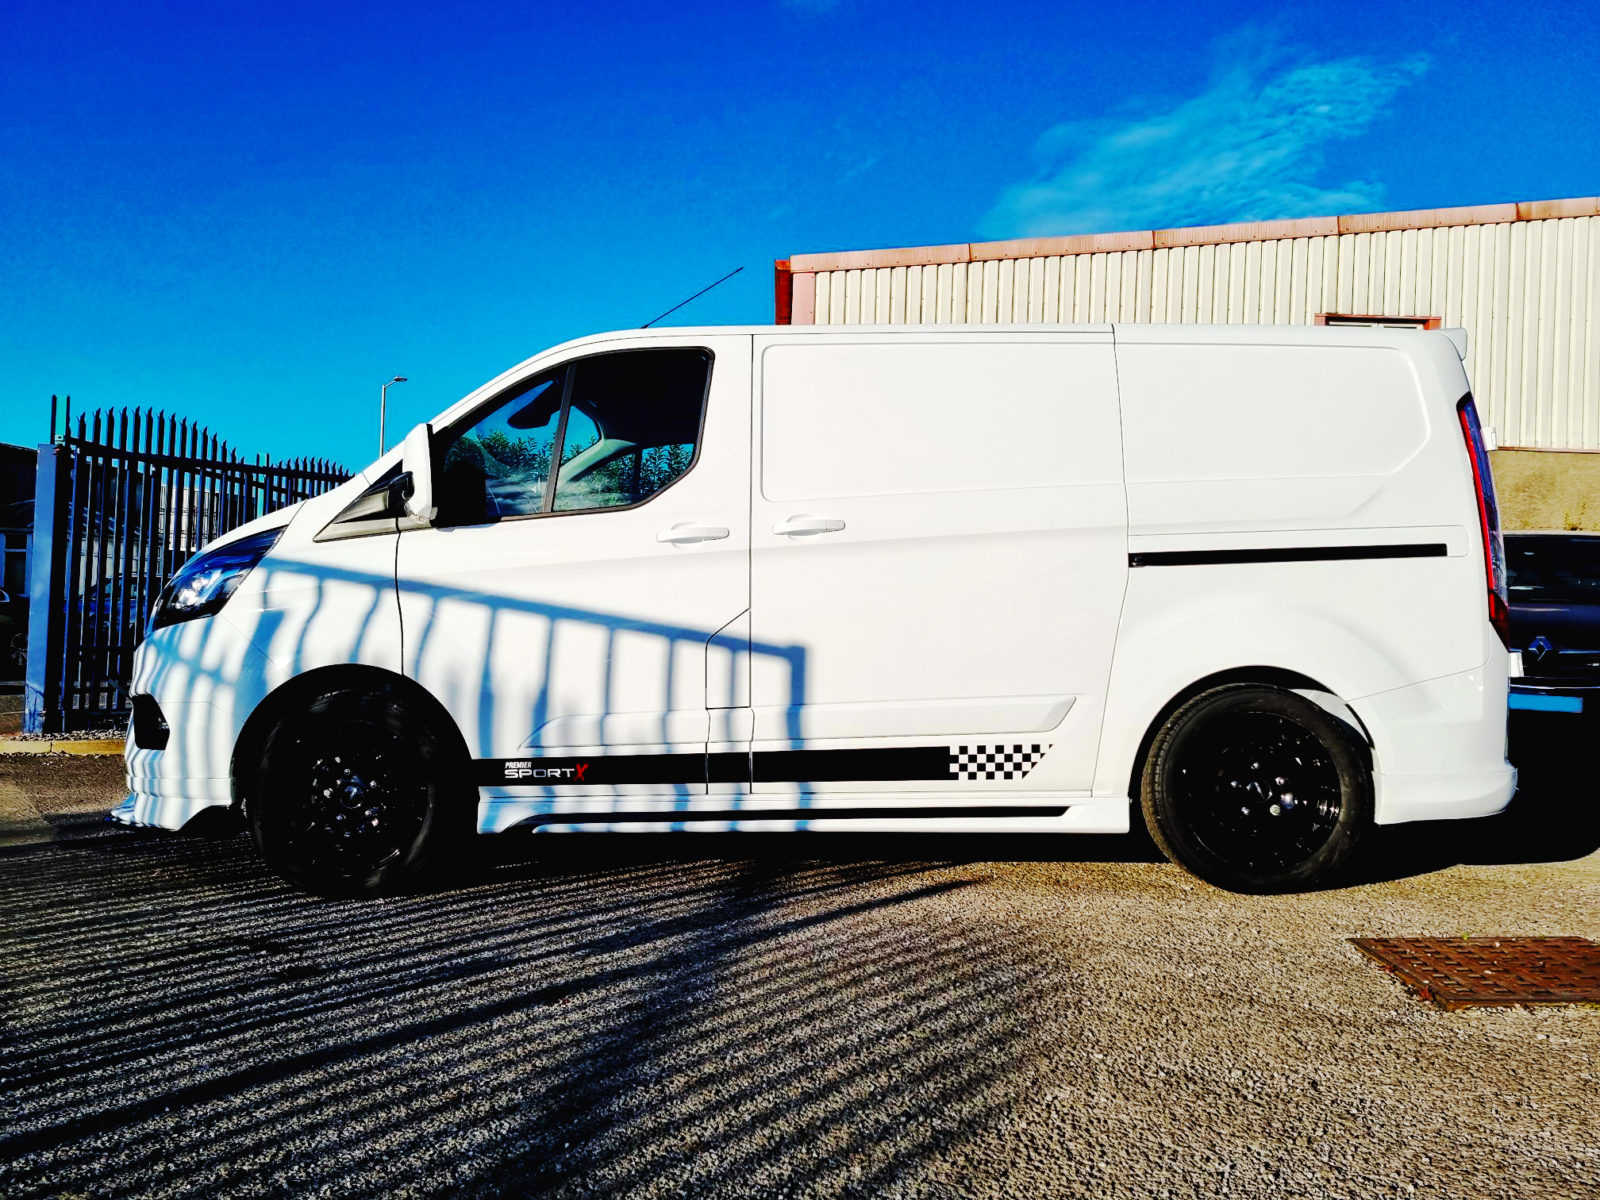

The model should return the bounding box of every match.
[0,835,1059,1197]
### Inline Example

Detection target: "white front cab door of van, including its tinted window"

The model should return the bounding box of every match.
[397,336,750,829]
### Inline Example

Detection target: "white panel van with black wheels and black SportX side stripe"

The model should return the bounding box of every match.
[117,325,1515,894]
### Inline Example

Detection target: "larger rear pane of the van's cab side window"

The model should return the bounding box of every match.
[554,347,710,512]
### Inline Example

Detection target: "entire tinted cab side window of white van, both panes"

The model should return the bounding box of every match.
[434,347,710,525]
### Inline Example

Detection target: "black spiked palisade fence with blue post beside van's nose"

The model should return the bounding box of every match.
[27,408,350,733]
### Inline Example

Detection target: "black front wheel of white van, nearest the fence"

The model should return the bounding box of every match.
[245,688,470,896]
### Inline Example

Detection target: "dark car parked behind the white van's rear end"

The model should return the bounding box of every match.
[1506,533,1600,712]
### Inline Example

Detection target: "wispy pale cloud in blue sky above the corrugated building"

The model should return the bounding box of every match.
[982,30,1429,238]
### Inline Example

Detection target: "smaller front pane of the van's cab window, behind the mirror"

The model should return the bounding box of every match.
[434,374,566,525]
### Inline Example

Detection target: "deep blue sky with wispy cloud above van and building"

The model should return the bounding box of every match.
[0,0,1600,467]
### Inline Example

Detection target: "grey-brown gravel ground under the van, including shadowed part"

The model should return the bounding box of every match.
[0,720,1600,1200]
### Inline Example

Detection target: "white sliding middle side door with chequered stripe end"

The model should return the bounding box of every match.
[750,330,1128,798]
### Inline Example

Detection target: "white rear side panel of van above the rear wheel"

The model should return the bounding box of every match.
[1094,326,1493,803]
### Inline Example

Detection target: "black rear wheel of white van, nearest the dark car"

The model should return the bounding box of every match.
[1139,683,1373,893]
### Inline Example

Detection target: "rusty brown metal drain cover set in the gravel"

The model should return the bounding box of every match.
[1350,938,1600,1008]
